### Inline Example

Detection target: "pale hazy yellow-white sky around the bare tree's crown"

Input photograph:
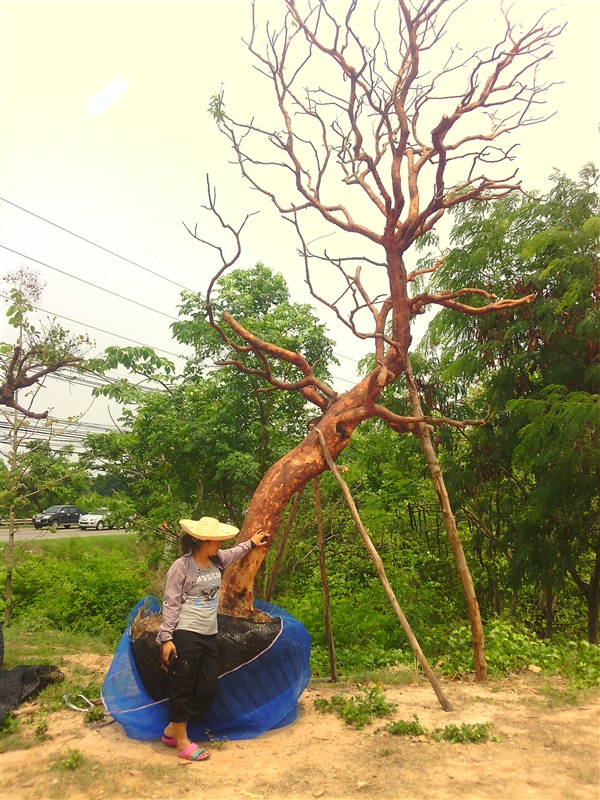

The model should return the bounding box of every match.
[0,0,600,434]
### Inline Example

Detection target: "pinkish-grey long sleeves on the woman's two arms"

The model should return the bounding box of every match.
[156,539,252,644]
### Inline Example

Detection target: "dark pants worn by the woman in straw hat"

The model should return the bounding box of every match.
[169,631,219,722]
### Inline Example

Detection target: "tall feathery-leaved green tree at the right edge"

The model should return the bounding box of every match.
[426,165,600,642]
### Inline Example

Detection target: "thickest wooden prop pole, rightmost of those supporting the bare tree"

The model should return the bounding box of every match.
[406,356,487,681]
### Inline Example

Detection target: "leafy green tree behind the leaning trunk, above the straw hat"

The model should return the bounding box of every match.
[87,263,335,525]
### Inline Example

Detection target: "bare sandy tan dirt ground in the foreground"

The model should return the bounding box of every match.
[0,655,600,800]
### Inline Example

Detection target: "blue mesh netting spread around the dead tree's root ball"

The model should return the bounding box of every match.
[102,596,310,741]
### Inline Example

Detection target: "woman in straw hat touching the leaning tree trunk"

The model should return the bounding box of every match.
[156,517,269,761]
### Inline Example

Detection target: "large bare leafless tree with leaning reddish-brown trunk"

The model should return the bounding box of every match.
[194,0,560,678]
